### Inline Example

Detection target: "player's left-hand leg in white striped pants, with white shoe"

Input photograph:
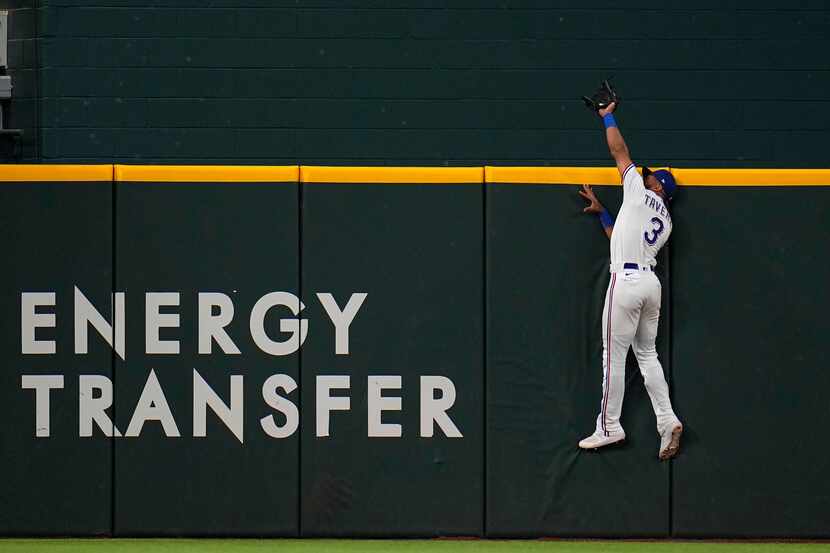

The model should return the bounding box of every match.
[580,273,641,449]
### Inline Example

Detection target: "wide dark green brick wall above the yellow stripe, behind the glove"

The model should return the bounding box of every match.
[34,0,830,167]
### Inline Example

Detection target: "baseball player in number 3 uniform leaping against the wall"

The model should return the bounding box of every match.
[579,102,683,460]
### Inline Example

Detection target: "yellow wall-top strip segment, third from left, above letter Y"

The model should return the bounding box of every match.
[300,165,484,184]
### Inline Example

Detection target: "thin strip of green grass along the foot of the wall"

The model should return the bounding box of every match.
[0,539,830,553]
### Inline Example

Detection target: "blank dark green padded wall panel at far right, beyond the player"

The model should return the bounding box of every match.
[672,187,830,538]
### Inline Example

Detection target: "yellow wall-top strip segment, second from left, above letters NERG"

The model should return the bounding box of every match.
[115,165,300,182]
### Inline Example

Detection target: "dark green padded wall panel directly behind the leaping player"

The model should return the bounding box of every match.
[486,184,682,537]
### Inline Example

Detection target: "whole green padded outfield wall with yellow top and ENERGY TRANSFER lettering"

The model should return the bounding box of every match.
[0,165,830,538]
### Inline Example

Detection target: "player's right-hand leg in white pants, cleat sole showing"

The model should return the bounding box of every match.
[633,274,682,457]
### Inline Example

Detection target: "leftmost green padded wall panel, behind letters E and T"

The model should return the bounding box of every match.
[0,182,112,536]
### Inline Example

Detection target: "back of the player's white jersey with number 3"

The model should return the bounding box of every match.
[611,163,672,272]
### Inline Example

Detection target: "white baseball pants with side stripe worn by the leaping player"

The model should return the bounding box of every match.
[596,270,678,436]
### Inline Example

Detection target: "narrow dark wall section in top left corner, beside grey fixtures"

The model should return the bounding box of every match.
[0,0,38,163]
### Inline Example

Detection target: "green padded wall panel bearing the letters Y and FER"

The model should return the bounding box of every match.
[301,183,484,536]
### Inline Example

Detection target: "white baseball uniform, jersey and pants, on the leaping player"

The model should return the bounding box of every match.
[596,163,679,436]
